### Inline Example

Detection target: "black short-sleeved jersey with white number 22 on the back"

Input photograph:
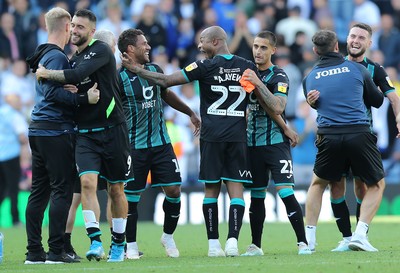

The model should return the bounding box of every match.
[182,55,258,142]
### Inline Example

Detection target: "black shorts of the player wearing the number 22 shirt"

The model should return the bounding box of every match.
[199,140,251,183]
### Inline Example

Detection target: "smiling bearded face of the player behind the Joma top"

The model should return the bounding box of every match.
[347,27,372,59]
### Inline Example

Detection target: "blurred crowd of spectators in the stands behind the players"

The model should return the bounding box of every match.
[0,0,400,224]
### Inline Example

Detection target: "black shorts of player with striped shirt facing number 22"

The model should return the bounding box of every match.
[125,144,182,194]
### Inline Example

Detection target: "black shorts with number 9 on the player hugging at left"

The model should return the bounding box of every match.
[75,123,134,183]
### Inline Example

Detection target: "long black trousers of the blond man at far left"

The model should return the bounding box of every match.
[25,134,76,254]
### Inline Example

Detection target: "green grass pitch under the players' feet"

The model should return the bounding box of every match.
[0,217,400,273]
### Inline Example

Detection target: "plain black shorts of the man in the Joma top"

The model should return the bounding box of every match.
[314,133,384,185]
